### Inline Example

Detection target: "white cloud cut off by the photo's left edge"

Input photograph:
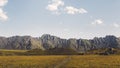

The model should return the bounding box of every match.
[0,0,8,21]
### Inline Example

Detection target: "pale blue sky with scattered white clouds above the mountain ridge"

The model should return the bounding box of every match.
[0,0,120,39]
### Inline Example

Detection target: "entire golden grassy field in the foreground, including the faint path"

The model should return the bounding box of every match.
[0,55,120,68]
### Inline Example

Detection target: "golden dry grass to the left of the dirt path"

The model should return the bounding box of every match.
[0,56,66,68]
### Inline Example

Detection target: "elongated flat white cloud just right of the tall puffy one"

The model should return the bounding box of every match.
[65,6,87,14]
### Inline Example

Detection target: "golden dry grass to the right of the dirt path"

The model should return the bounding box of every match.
[64,55,120,68]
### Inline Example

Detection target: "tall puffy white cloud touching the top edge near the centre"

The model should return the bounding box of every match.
[47,0,64,11]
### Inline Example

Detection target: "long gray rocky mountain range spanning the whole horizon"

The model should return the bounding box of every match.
[0,34,120,52]
